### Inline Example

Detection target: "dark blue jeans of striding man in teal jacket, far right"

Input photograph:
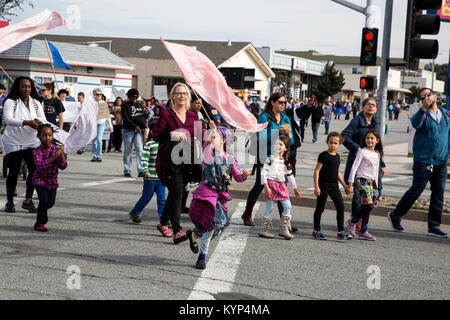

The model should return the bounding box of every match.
[392,161,447,229]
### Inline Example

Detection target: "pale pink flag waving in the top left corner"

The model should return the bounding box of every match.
[0,9,67,52]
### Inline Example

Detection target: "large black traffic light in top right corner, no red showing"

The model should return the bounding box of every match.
[404,0,442,70]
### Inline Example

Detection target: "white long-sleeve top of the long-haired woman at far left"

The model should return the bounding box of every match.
[3,97,46,154]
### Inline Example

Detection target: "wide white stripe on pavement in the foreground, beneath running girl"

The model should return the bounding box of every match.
[188,202,259,300]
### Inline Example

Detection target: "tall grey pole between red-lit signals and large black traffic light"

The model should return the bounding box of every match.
[375,0,394,142]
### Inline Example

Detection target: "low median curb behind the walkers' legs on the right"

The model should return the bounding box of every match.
[229,190,450,225]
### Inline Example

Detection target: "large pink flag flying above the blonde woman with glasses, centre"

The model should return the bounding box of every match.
[161,38,267,132]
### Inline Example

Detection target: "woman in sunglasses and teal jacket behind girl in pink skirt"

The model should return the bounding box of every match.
[242,92,294,226]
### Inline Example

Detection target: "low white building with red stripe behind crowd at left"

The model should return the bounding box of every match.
[0,39,134,101]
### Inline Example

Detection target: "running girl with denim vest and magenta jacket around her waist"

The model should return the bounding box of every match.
[186,127,250,269]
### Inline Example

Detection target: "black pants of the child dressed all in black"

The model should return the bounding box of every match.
[314,183,344,232]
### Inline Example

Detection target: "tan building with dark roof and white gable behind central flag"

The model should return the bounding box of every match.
[37,35,275,100]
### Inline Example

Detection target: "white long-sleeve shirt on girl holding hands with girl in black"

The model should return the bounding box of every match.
[348,148,380,183]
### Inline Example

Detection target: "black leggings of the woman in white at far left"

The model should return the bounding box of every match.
[6,148,36,202]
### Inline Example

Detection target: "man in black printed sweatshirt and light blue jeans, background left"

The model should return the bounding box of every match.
[121,88,148,177]
